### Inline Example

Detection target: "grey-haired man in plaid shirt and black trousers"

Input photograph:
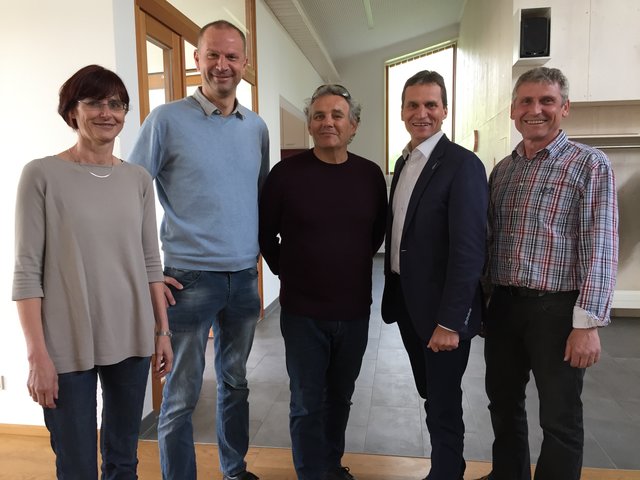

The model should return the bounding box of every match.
[484,67,618,480]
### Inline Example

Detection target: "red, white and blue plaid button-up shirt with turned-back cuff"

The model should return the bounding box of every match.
[488,131,618,328]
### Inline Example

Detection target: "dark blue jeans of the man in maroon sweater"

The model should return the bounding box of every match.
[280,310,369,480]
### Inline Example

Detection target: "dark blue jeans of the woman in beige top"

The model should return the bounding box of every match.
[44,357,149,480]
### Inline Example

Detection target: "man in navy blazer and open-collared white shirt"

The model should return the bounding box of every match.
[382,70,488,480]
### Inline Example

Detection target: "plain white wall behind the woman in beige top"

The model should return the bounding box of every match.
[0,0,138,425]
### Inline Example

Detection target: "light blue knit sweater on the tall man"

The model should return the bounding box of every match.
[129,92,269,272]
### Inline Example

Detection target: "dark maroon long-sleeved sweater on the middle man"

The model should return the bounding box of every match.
[259,150,387,321]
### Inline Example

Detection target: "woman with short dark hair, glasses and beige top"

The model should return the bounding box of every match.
[13,65,172,480]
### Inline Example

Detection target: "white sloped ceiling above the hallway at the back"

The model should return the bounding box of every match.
[265,0,466,81]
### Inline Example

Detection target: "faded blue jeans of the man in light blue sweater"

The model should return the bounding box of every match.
[158,267,260,480]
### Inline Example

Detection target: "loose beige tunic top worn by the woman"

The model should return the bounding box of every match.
[13,157,163,373]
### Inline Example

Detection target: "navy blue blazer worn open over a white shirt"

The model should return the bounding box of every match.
[382,135,488,341]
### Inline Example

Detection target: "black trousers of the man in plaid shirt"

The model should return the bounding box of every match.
[484,288,584,480]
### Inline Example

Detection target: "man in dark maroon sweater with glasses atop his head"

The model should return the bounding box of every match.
[259,85,387,480]
